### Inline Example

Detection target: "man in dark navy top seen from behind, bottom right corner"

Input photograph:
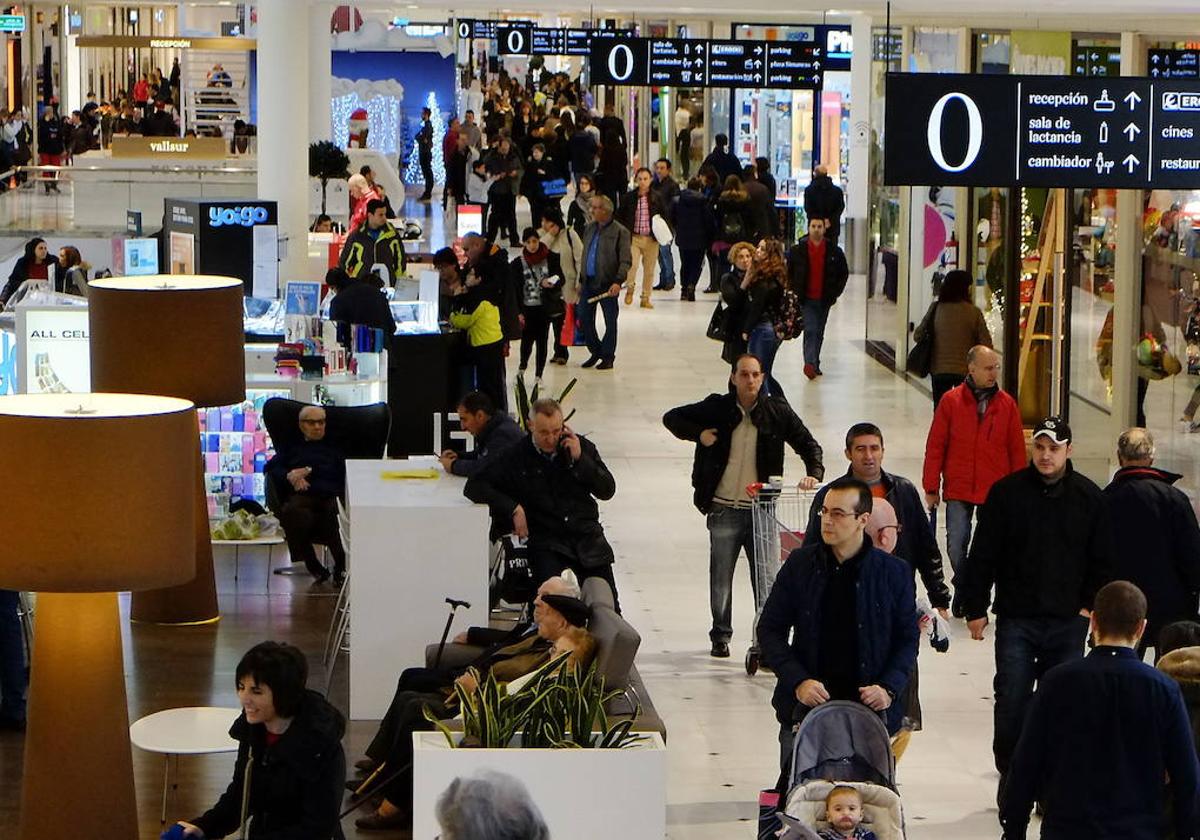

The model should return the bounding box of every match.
[1000,581,1200,840]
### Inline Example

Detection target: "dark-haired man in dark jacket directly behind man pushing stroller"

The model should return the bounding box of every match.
[804,422,950,618]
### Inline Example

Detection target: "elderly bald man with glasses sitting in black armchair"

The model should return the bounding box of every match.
[266,406,346,586]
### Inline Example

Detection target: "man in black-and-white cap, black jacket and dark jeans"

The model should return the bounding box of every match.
[943,417,1116,796]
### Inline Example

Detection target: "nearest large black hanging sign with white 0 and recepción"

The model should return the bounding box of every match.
[883,73,1200,190]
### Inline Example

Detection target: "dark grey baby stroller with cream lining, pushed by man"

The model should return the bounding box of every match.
[780,701,905,840]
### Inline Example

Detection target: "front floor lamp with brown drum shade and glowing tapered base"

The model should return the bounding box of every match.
[0,394,199,840]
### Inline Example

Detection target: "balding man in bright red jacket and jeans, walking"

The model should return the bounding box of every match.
[923,344,1027,618]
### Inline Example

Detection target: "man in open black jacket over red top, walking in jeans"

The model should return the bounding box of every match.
[787,218,850,379]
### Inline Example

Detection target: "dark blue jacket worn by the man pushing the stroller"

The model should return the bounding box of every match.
[758,535,919,726]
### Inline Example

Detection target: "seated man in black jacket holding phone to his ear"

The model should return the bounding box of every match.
[463,400,619,612]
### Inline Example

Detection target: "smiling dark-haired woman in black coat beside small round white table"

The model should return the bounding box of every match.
[171,642,346,840]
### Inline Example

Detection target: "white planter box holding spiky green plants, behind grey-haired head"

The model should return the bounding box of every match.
[413,732,667,840]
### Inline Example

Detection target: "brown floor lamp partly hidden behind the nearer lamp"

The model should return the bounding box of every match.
[88,275,246,624]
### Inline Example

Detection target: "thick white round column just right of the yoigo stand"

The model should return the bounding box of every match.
[258,0,310,287]
